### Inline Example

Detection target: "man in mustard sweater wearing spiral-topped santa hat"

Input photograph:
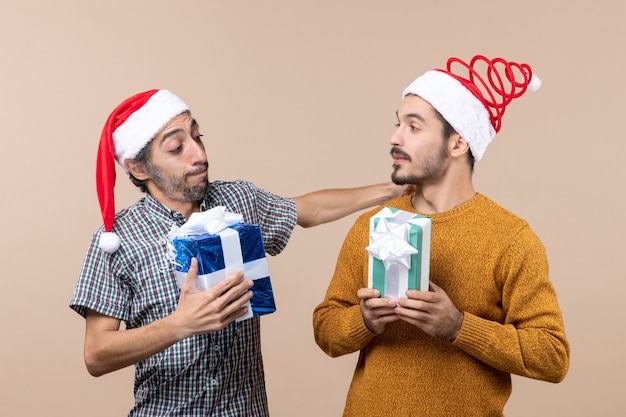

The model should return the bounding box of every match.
[313,56,570,417]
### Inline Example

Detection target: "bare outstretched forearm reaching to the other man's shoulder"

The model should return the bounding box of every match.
[293,182,406,227]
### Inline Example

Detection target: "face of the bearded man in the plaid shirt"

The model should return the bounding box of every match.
[146,113,209,202]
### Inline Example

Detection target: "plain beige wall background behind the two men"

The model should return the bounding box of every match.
[0,0,626,417]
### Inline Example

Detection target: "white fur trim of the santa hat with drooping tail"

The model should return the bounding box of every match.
[113,90,189,173]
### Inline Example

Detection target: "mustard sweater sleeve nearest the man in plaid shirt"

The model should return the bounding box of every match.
[313,216,375,357]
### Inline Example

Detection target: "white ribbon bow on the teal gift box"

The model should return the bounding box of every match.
[365,217,418,271]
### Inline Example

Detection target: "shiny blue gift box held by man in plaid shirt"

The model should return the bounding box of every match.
[170,223,276,320]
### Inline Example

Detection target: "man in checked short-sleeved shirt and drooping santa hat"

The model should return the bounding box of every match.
[70,90,403,416]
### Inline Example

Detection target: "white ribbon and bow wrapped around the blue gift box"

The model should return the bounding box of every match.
[168,206,270,320]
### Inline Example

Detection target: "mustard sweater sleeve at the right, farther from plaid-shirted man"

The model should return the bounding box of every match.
[454,226,570,382]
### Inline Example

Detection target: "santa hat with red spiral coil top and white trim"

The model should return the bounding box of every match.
[402,55,541,161]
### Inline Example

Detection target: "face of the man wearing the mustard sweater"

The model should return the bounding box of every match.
[389,95,450,185]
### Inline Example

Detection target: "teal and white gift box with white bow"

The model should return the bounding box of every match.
[366,207,432,298]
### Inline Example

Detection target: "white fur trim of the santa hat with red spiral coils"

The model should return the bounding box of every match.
[402,70,496,161]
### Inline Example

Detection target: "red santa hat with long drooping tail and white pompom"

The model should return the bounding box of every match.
[96,90,189,253]
